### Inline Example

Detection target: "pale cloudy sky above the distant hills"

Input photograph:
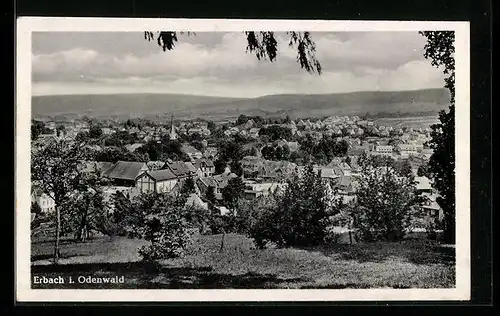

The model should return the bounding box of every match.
[32,32,444,98]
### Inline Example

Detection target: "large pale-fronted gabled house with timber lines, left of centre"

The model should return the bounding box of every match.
[136,169,179,193]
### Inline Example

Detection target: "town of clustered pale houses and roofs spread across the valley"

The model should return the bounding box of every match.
[32,115,443,227]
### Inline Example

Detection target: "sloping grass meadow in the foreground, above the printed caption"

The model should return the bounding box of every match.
[32,235,455,289]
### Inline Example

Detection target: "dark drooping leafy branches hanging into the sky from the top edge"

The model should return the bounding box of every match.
[144,31,322,74]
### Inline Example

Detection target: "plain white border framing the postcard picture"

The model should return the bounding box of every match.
[15,17,470,302]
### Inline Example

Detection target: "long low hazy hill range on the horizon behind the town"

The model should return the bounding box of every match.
[32,89,449,120]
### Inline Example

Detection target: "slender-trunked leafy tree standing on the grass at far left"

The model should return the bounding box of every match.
[31,140,88,264]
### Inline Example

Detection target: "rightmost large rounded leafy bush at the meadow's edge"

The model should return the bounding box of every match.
[356,166,422,241]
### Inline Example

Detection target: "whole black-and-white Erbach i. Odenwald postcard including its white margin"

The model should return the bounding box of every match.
[16,18,470,301]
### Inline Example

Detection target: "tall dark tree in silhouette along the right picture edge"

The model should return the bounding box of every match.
[420,31,456,243]
